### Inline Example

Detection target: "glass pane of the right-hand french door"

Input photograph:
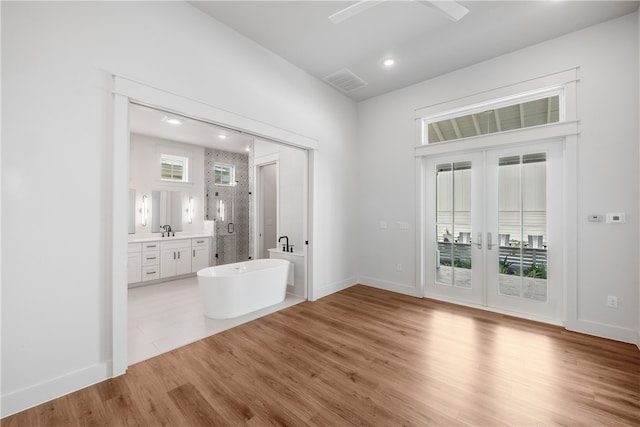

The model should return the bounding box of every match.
[498,153,547,301]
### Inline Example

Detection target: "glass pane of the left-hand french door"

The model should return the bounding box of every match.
[436,162,471,288]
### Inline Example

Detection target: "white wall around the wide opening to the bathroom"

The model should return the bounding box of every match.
[1,2,357,415]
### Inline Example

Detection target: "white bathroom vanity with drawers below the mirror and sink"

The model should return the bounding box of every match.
[128,235,211,287]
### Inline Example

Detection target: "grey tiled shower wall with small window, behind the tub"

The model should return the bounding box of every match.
[204,148,253,265]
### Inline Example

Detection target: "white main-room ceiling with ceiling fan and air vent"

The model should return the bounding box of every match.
[189,0,639,101]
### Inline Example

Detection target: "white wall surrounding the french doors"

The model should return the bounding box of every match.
[358,14,639,340]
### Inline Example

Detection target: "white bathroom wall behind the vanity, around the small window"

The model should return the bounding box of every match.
[129,134,206,238]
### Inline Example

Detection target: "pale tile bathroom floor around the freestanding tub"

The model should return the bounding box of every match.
[128,277,304,365]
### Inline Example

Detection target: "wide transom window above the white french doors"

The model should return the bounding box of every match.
[424,89,563,144]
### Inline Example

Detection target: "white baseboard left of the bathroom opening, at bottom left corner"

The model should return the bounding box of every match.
[0,363,111,418]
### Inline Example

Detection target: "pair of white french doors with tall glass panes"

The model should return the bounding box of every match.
[424,141,564,323]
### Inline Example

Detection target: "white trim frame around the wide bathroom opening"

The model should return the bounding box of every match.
[114,75,318,377]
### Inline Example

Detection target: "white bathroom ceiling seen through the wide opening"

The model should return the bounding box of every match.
[129,104,253,153]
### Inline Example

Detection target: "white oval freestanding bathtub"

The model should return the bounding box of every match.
[198,259,291,319]
